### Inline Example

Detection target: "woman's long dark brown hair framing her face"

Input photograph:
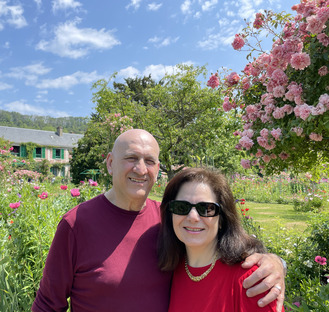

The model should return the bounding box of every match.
[158,168,266,271]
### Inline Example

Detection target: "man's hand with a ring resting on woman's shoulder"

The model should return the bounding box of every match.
[242,253,285,312]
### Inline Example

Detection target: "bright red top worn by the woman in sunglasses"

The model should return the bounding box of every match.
[169,260,284,312]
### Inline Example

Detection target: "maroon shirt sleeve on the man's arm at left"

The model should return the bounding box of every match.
[32,219,76,312]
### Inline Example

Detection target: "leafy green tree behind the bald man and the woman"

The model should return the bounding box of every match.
[93,65,241,178]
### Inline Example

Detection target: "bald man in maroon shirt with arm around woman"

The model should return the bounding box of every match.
[32,129,284,312]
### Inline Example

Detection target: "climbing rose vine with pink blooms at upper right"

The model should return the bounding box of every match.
[208,0,329,173]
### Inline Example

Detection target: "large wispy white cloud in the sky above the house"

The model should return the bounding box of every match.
[36,19,121,59]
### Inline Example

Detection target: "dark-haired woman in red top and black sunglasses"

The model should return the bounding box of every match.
[159,168,282,312]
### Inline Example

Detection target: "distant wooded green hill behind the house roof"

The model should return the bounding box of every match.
[0,110,89,134]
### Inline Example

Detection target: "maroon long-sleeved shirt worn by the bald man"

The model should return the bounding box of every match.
[32,195,172,312]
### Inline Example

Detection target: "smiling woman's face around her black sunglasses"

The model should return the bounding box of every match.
[172,182,219,251]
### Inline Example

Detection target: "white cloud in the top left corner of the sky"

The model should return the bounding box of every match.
[0,0,27,30]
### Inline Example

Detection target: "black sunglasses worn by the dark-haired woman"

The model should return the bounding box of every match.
[169,200,221,217]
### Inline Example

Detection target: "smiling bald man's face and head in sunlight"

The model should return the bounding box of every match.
[107,132,159,208]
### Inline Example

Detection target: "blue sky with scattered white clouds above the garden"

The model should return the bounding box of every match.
[0,0,298,117]
